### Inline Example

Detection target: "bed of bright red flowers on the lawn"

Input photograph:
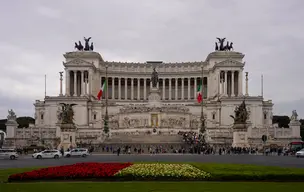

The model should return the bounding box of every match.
[8,163,132,181]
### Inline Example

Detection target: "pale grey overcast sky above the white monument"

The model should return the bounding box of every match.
[0,0,304,119]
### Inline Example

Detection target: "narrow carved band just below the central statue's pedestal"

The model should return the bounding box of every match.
[120,106,189,114]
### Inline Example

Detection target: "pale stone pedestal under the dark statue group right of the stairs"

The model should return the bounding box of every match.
[232,123,249,147]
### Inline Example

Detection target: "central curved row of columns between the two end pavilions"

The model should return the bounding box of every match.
[101,77,208,100]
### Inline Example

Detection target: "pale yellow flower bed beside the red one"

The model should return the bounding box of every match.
[116,163,210,180]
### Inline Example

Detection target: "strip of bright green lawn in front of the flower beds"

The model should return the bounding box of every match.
[0,182,304,192]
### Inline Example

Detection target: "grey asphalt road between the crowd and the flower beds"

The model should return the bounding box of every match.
[0,154,304,169]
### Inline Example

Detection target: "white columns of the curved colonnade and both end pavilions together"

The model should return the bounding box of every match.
[66,70,243,100]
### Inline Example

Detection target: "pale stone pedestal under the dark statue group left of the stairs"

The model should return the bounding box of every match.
[58,124,76,150]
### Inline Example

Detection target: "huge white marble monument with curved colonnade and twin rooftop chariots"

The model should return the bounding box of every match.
[7,38,300,146]
